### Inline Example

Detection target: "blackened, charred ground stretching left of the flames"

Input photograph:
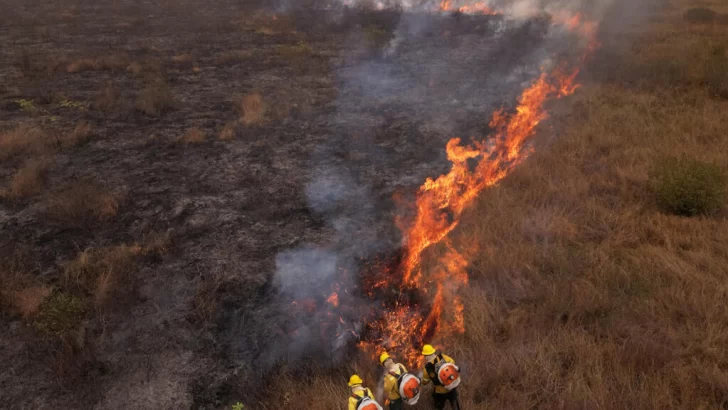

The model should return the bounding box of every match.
[0,0,564,409]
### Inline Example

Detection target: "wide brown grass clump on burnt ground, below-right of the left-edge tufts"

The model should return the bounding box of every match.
[46,182,119,226]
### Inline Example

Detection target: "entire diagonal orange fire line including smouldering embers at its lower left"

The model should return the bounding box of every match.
[286,7,598,372]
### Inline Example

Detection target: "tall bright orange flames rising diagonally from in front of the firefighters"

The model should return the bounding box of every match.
[359,12,598,364]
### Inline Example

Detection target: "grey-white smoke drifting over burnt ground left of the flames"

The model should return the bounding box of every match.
[260,0,660,370]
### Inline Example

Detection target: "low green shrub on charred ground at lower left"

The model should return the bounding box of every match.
[35,292,84,336]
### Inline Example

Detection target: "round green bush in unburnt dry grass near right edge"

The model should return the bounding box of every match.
[650,156,726,216]
